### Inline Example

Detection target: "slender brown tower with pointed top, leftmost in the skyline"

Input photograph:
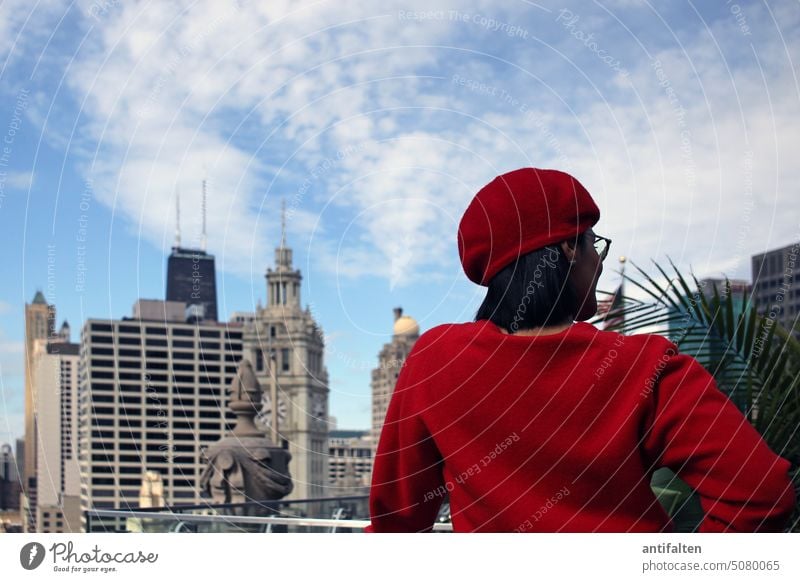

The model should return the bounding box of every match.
[22,291,56,532]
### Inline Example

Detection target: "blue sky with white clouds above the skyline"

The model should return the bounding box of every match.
[0,0,800,448]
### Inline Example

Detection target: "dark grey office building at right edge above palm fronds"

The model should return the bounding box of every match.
[751,242,800,339]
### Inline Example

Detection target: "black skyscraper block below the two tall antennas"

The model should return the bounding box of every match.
[167,247,217,321]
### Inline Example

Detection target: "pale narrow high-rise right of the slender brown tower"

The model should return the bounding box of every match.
[34,338,81,533]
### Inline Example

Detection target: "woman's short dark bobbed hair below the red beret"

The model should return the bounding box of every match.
[475,233,586,333]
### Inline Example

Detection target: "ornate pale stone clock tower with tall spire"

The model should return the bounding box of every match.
[244,204,329,499]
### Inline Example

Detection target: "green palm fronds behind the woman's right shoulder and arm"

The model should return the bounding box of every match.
[594,260,800,531]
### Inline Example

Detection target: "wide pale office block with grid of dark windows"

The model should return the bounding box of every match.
[79,300,243,531]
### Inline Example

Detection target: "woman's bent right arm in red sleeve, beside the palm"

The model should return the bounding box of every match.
[643,352,795,532]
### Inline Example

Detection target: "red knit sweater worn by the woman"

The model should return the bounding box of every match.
[367,321,795,532]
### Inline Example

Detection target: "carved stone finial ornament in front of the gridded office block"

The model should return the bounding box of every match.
[200,360,293,503]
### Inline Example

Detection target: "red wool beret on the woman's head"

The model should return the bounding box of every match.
[458,168,600,285]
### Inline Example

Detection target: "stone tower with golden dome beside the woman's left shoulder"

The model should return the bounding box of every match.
[371,307,419,447]
